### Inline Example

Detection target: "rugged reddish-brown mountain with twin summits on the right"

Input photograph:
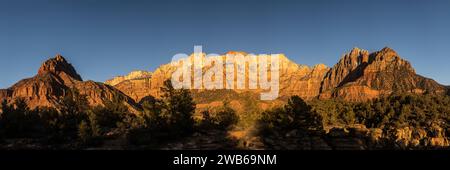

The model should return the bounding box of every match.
[320,47,446,101]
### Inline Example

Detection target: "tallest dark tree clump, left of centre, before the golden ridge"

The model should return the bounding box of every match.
[122,80,195,144]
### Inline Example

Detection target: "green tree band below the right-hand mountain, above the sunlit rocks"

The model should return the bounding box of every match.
[310,94,450,129]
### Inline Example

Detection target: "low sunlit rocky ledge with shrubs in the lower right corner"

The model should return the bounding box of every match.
[325,124,450,150]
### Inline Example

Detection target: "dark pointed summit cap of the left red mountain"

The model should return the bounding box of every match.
[38,54,82,81]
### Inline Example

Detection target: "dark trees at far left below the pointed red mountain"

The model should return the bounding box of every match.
[0,90,128,144]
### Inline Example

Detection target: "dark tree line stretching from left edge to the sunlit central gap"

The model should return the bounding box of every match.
[0,81,238,148]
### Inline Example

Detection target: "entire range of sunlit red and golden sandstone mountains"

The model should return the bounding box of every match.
[0,48,442,113]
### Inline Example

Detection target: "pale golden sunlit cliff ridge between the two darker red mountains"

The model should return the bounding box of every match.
[105,51,329,101]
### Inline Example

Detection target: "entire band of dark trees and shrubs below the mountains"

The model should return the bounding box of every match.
[0,81,450,149]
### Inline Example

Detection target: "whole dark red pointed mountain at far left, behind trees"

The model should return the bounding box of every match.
[0,55,136,112]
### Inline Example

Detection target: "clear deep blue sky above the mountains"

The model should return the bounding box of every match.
[0,0,450,88]
